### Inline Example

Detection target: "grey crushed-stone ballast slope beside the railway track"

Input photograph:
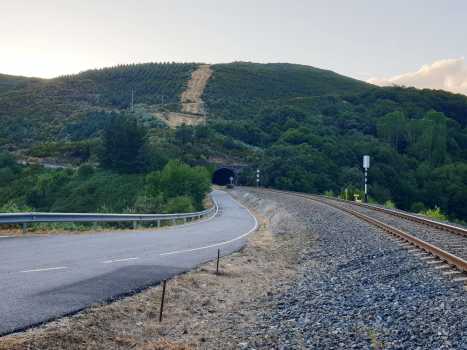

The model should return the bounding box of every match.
[229,188,467,350]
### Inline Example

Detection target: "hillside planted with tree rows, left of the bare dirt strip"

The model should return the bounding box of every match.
[0,63,197,144]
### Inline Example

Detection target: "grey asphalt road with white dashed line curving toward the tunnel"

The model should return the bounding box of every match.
[0,191,258,335]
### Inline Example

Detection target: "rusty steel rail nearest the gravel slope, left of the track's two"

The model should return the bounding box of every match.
[252,187,467,272]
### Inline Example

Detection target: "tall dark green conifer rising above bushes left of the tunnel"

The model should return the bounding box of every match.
[99,114,147,174]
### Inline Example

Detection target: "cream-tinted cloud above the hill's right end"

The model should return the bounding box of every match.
[367,57,467,95]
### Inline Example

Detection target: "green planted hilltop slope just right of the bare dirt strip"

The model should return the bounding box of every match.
[202,62,372,120]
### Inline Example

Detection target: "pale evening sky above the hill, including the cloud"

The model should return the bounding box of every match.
[0,0,467,95]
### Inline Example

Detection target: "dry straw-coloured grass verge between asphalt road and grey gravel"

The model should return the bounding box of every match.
[0,201,318,350]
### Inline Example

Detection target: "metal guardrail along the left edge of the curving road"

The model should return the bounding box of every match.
[0,195,217,233]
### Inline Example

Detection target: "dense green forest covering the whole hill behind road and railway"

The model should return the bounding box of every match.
[0,62,467,222]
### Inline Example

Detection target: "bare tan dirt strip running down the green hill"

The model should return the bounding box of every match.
[156,64,212,129]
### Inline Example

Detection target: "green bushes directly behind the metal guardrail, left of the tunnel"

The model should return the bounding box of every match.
[0,152,211,219]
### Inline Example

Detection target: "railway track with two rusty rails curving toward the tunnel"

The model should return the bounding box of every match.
[252,188,467,291]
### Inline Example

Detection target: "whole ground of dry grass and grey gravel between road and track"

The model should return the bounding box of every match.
[0,187,467,350]
